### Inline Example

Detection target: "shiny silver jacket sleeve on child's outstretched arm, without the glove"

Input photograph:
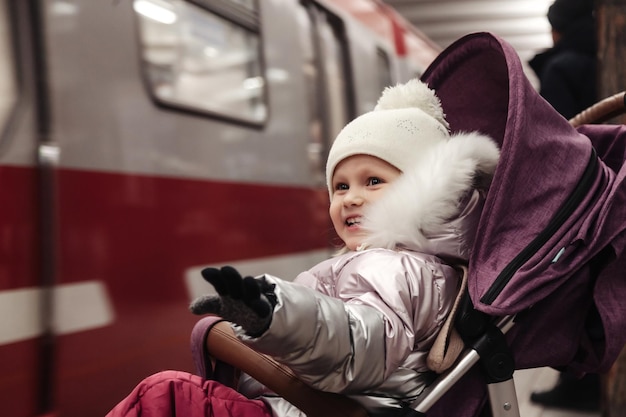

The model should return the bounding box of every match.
[232,252,445,393]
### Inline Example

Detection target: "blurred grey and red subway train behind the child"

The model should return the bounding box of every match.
[0,0,440,417]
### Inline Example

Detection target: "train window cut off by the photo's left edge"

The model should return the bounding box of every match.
[0,1,17,133]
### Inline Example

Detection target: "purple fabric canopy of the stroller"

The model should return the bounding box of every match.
[422,33,626,371]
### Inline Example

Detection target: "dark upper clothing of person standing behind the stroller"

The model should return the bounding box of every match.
[529,0,597,119]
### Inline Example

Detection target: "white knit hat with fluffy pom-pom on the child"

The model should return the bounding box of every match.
[326,79,450,196]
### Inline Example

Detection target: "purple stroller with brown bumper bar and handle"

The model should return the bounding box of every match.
[192,33,626,417]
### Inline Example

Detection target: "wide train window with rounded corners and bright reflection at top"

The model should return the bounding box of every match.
[133,0,267,123]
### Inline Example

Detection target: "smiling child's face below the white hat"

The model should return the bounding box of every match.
[329,155,402,250]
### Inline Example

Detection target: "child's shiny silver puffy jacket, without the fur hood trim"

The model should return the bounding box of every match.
[240,249,458,416]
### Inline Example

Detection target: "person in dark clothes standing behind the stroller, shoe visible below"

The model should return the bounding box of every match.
[529,0,600,411]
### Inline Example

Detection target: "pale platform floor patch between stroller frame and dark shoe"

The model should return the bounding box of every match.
[513,368,601,417]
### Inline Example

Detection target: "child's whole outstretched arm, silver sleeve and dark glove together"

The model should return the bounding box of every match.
[191,251,443,393]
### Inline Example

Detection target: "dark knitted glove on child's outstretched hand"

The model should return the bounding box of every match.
[189,266,276,337]
